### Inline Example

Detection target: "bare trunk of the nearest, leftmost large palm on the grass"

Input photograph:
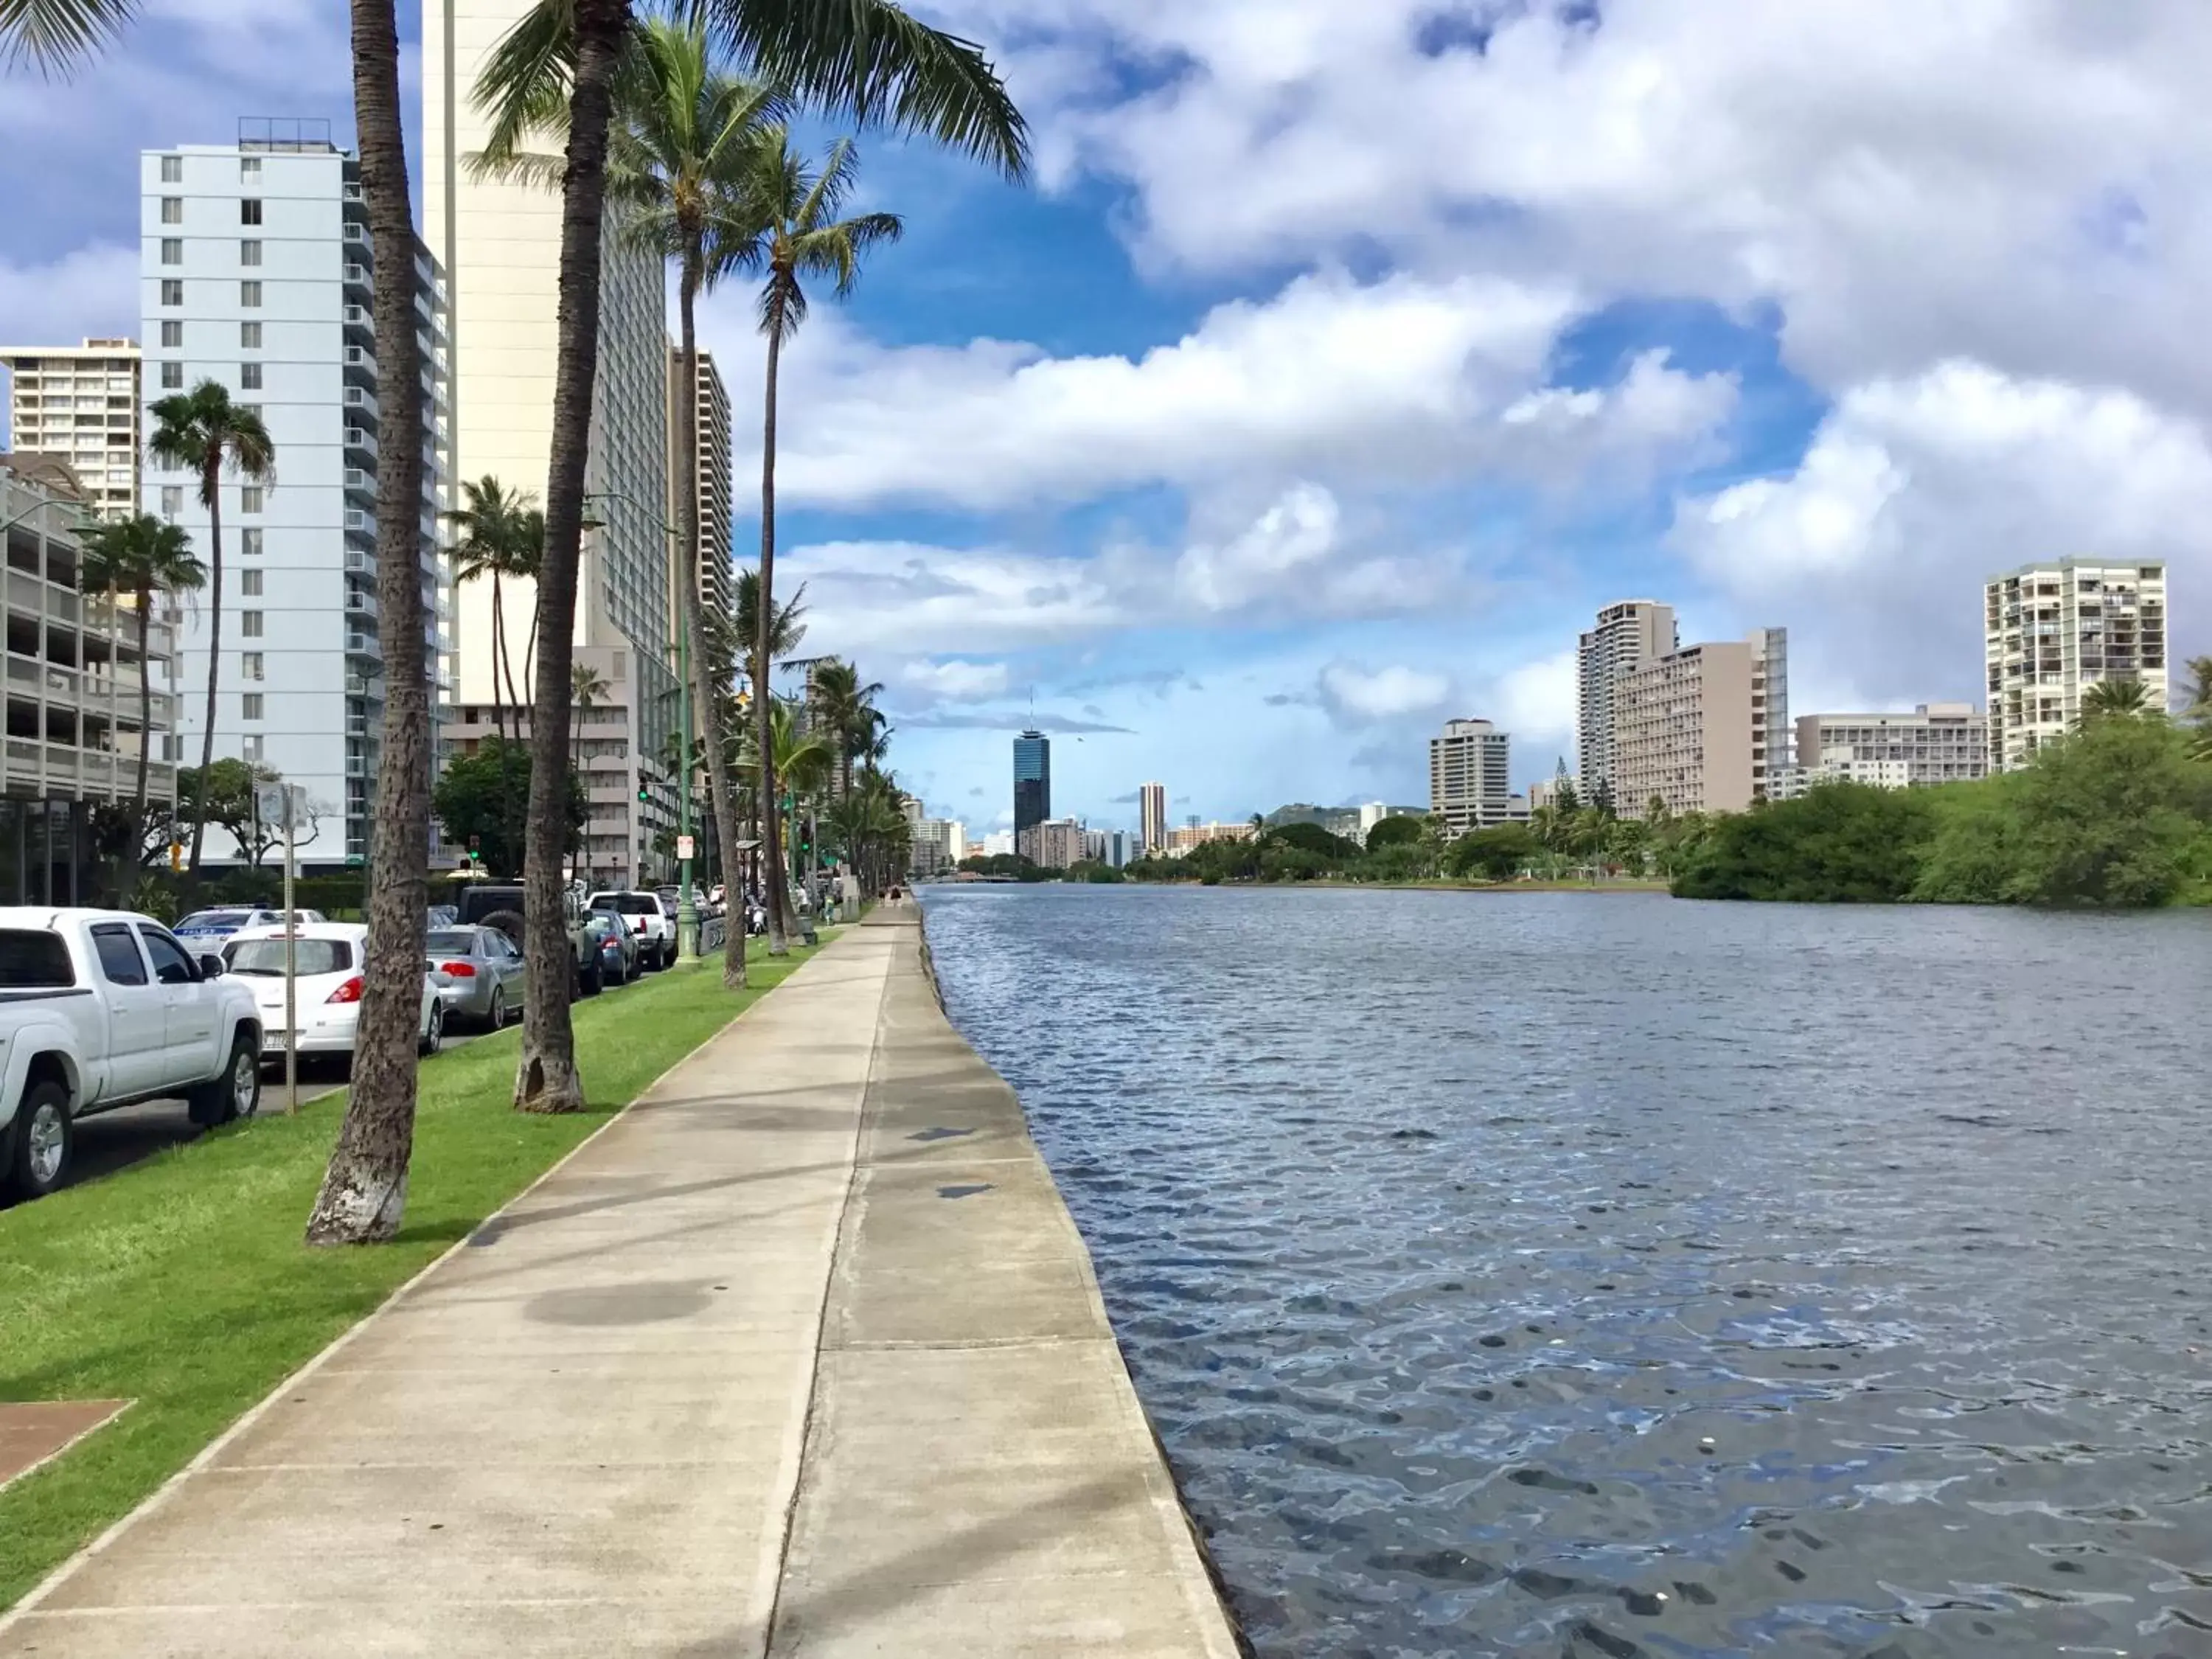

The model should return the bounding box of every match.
[307,0,431,1245]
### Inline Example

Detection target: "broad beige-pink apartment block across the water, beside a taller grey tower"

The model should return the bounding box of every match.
[1610,628,1790,818]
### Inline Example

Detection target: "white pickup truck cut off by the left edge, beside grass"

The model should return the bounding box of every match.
[0,905,261,1199]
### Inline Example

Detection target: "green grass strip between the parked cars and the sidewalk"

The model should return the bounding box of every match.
[0,945,832,1608]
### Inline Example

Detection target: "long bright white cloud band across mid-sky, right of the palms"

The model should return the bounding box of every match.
[701,272,1734,509]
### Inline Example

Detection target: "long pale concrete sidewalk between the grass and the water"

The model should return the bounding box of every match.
[0,907,1234,1659]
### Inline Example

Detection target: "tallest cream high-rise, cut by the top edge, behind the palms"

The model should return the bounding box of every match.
[422,0,679,845]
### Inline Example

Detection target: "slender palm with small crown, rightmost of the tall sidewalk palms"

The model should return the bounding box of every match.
[752,128,900,956]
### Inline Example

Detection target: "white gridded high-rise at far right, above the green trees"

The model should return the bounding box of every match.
[1982,560,2170,772]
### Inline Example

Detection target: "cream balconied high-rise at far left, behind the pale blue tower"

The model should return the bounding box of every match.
[0,338,146,518]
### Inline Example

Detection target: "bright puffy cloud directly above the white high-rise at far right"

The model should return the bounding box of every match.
[1672,361,2212,708]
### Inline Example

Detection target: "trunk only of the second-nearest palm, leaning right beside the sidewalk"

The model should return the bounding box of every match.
[515,0,630,1113]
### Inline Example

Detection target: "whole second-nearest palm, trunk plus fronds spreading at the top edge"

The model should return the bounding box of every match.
[469,0,1029,1110]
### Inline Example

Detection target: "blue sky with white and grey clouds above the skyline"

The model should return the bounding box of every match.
[0,0,2212,834]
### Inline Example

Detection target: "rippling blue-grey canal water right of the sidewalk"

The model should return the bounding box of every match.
[925,887,2212,1659]
